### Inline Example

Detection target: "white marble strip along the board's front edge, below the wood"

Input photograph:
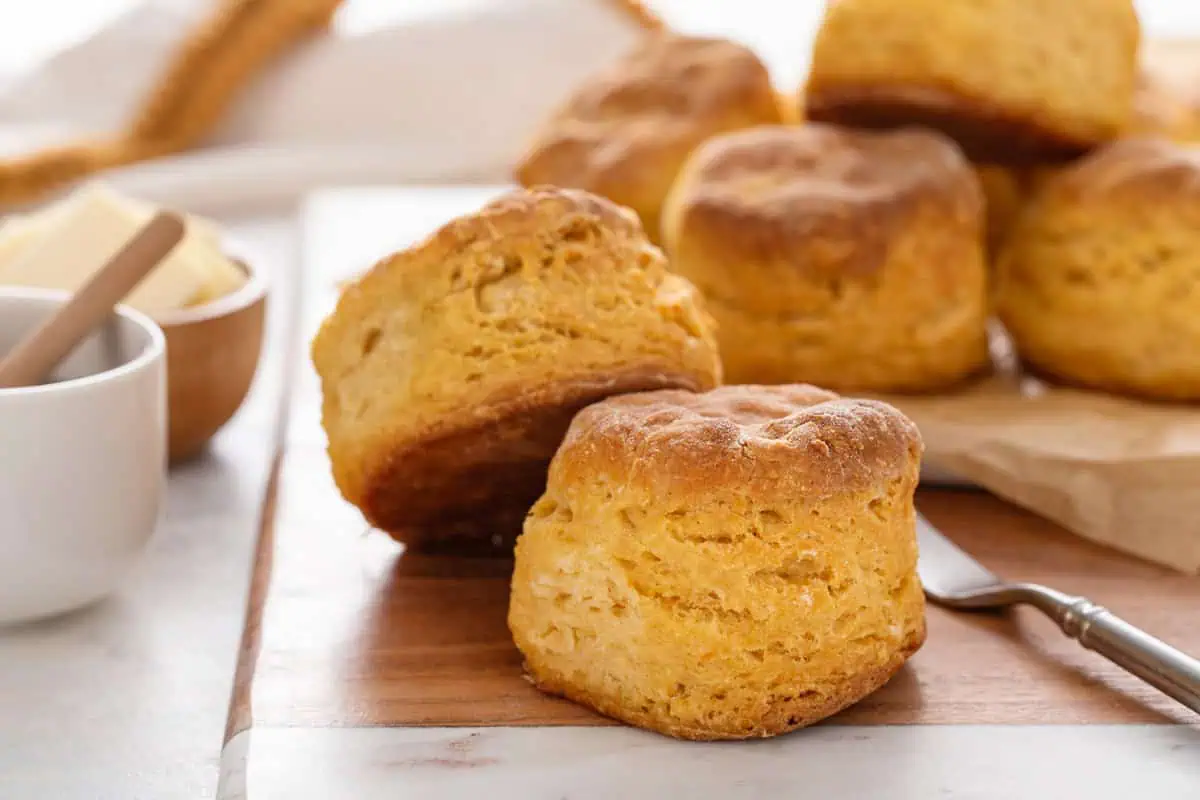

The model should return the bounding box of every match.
[220,726,1200,800]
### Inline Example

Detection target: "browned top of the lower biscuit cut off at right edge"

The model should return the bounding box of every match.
[1038,137,1200,203]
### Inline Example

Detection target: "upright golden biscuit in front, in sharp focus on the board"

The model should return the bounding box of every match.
[509,386,925,739]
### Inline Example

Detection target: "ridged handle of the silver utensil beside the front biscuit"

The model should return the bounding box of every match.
[1056,591,1200,712]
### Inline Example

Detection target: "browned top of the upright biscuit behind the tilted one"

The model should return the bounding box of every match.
[664,122,983,273]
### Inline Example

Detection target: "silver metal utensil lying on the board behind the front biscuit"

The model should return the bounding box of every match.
[917,513,1200,712]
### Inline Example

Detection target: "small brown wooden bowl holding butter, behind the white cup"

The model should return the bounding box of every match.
[155,260,266,464]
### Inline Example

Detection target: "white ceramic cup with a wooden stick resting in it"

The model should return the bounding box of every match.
[0,287,167,624]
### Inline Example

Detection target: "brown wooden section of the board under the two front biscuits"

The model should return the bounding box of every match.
[227,190,1200,738]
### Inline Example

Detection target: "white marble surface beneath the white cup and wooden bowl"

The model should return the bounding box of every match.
[0,219,294,800]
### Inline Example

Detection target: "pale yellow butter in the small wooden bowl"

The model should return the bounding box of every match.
[0,185,245,314]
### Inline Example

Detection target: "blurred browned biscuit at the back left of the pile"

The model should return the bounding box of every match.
[516,35,781,240]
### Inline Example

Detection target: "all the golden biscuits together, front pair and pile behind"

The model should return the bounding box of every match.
[312,0,1200,739]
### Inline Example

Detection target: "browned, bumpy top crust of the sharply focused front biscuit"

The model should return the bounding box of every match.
[551,384,922,498]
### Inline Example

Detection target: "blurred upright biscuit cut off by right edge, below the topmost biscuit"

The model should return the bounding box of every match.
[996,139,1200,399]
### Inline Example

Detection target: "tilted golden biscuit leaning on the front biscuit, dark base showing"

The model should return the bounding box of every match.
[312,188,720,551]
